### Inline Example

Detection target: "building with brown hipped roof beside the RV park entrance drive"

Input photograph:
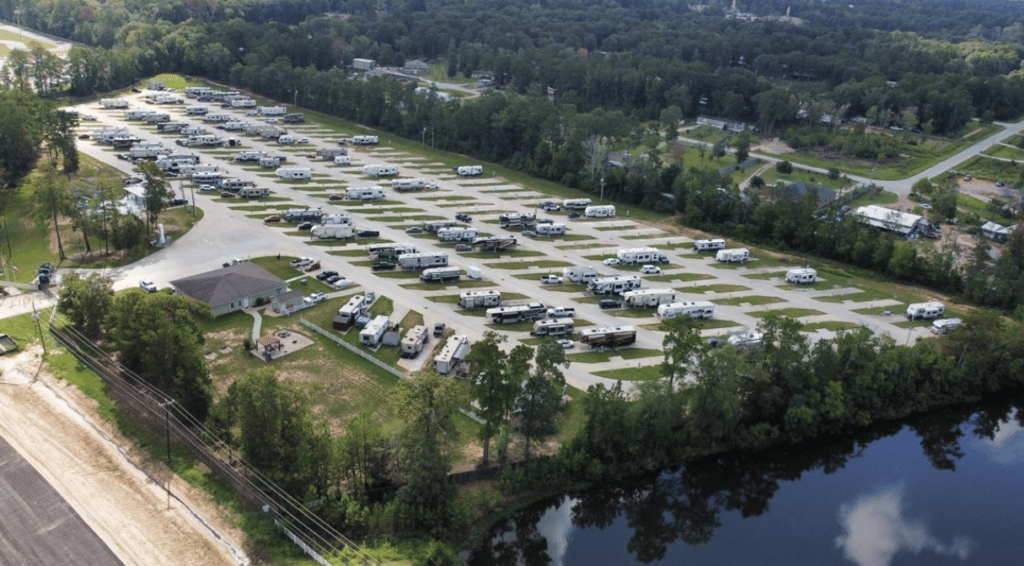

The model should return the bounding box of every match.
[171,261,288,316]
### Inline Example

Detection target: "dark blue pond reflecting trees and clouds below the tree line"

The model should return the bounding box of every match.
[464,398,1024,566]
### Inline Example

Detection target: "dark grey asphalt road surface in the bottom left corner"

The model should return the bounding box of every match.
[0,437,124,566]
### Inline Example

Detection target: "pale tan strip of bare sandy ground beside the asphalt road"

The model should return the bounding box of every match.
[0,345,249,566]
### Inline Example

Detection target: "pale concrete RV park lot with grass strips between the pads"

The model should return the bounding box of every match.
[66,88,928,388]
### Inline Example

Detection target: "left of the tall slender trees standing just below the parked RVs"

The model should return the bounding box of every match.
[466,331,521,466]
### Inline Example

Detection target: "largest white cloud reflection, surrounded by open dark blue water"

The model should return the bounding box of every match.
[836,485,971,566]
